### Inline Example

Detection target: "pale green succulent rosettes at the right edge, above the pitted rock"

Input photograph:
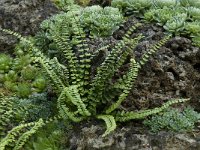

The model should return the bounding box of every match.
[144,4,200,46]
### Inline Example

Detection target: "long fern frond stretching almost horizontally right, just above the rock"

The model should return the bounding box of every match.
[115,99,190,122]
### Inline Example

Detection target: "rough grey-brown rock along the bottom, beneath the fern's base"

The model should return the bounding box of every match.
[69,124,200,150]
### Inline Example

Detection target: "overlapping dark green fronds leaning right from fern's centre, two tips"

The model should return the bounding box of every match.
[88,24,142,111]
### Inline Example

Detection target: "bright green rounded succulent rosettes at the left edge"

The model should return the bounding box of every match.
[0,52,46,98]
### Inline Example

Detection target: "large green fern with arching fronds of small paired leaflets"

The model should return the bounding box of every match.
[0,14,188,148]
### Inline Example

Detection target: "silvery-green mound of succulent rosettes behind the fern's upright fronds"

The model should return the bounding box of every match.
[38,6,123,38]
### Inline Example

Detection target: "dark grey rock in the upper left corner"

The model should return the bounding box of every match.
[0,0,57,51]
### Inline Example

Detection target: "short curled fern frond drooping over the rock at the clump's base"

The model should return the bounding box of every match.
[97,115,117,137]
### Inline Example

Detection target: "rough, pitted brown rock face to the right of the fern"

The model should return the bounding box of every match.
[116,19,200,110]
